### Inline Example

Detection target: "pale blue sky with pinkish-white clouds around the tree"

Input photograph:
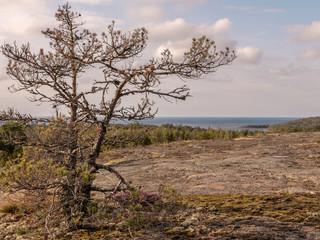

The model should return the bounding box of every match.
[0,0,320,117]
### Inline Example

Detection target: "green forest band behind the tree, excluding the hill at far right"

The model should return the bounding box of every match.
[0,122,264,163]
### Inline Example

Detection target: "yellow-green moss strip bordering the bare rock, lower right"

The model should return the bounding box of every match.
[184,193,320,227]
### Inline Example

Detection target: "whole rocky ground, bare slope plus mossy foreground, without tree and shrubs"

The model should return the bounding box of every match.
[0,133,320,240]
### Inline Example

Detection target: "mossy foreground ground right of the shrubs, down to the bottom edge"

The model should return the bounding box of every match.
[53,193,320,239]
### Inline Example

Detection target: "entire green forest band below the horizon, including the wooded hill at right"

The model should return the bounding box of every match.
[0,117,320,162]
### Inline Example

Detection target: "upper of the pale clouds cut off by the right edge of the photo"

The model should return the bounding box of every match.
[288,21,320,42]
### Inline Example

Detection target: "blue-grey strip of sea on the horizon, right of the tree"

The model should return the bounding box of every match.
[133,117,298,131]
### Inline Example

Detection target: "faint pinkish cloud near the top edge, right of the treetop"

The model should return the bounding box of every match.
[128,6,166,20]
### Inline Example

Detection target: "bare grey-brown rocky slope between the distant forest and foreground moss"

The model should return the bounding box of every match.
[96,133,320,194]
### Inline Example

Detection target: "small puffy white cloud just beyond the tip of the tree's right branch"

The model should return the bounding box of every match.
[236,46,263,64]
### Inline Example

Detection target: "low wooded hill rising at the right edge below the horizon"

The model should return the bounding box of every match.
[267,117,320,133]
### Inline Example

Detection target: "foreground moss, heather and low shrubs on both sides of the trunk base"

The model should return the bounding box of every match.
[0,189,320,240]
